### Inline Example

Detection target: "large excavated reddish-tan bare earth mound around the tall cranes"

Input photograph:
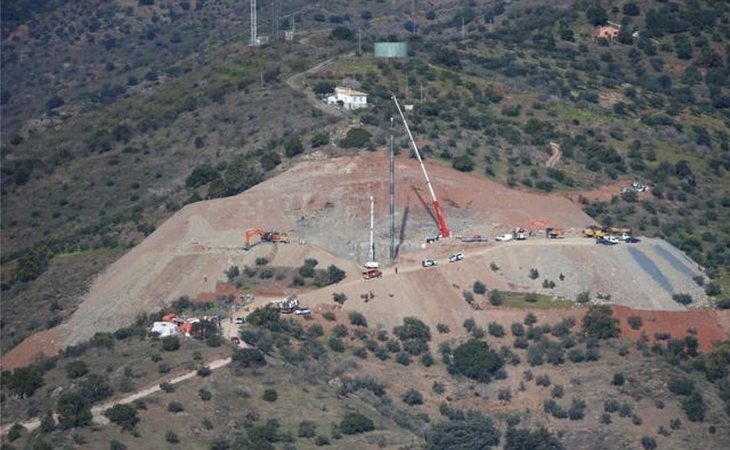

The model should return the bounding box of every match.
[2,151,724,367]
